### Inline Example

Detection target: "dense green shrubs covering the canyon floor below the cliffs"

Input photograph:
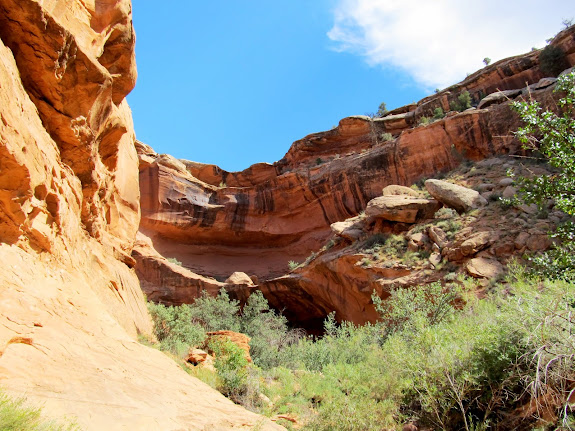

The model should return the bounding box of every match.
[150,272,575,430]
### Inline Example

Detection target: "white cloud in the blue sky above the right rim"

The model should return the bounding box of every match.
[328,0,575,88]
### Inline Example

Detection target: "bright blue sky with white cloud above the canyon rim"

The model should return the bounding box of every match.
[128,0,575,171]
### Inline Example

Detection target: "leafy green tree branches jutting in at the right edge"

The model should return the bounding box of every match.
[512,72,575,281]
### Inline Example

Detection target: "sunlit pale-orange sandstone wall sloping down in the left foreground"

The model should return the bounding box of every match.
[0,0,281,430]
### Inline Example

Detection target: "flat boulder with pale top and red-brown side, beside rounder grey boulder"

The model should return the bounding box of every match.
[365,196,441,223]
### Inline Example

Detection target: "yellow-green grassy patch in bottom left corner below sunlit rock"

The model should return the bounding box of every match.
[0,390,79,431]
